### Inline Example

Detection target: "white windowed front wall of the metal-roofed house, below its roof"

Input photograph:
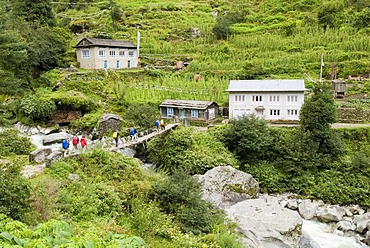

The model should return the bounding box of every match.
[229,92,304,120]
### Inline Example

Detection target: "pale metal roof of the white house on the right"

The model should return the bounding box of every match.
[225,79,307,92]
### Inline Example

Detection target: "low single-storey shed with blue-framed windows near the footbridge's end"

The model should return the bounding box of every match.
[159,100,219,121]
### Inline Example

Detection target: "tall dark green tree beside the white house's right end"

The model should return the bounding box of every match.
[300,85,344,156]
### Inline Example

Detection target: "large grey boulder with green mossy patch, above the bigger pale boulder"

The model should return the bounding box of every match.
[198,166,259,208]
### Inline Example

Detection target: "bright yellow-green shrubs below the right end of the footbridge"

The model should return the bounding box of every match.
[148,128,238,174]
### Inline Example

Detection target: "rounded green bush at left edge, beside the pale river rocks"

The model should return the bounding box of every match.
[0,129,32,156]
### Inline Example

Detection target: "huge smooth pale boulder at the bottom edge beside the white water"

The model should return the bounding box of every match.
[227,199,302,248]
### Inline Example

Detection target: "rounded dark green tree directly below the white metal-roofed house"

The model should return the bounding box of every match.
[224,115,273,163]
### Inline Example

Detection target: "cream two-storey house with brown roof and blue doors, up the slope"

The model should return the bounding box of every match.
[75,38,139,70]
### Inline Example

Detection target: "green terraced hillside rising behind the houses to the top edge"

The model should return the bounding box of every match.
[0,0,370,128]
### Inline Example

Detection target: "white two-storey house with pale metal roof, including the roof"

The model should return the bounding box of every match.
[226,79,306,121]
